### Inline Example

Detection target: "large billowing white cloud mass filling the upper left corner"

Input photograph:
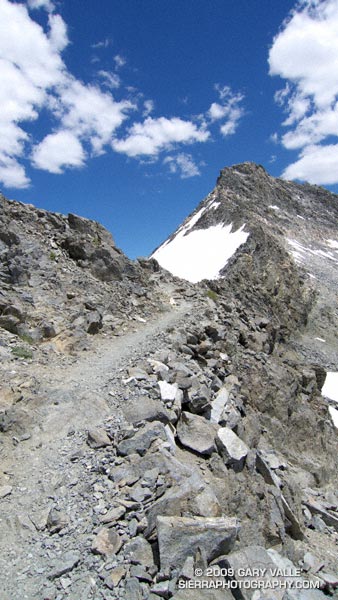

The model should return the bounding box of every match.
[0,0,134,187]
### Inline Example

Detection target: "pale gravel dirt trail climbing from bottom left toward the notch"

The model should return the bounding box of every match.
[0,302,192,600]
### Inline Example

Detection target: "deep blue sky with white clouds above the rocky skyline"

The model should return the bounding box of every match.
[0,0,338,257]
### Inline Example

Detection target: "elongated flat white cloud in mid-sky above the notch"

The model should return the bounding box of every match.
[112,117,210,157]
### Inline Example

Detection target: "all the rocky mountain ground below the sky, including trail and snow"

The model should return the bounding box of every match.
[0,163,338,600]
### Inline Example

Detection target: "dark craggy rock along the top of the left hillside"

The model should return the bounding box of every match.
[0,196,139,283]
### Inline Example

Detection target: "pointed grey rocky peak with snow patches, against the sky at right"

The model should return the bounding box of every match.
[153,163,338,356]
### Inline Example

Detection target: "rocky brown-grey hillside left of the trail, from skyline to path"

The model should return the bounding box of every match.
[0,195,194,351]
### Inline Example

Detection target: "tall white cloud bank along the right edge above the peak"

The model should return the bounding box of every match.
[269,0,338,184]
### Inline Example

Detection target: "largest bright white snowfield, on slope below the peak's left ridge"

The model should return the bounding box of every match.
[152,223,249,283]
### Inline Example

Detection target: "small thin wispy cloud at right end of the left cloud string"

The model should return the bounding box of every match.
[207,85,244,137]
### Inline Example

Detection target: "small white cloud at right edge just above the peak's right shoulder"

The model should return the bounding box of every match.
[283,144,338,185]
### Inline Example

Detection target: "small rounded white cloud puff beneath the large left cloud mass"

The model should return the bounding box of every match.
[32,131,85,173]
